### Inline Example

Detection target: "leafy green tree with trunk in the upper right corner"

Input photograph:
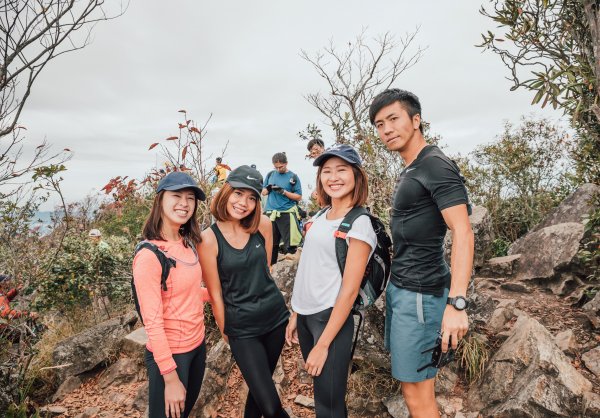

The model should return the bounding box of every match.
[479,0,600,183]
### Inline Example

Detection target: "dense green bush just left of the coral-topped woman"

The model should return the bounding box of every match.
[36,233,133,314]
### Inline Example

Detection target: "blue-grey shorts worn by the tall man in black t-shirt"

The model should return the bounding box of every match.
[385,282,448,383]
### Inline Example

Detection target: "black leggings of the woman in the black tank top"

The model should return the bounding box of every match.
[229,321,289,418]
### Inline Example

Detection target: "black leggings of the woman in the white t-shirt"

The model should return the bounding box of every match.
[298,308,354,418]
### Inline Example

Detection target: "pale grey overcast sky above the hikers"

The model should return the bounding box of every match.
[20,0,561,209]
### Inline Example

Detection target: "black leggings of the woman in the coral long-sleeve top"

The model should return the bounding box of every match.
[145,342,206,418]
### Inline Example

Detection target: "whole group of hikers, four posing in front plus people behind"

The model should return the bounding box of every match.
[133,89,473,418]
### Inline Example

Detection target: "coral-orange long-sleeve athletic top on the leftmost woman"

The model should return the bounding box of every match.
[133,240,205,375]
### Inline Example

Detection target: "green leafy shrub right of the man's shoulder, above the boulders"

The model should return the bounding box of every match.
[456,118,574,243]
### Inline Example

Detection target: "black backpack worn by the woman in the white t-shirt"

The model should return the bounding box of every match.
[313,206,392,370]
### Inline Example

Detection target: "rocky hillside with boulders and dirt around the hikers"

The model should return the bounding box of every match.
[32,185,600,418]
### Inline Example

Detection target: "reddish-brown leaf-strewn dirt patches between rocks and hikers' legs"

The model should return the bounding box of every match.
[44,287,600,418]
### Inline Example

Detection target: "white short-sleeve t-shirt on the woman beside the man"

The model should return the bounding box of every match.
[292,209,377,315]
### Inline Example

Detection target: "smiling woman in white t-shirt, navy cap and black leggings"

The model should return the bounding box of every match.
[286,145,377,418]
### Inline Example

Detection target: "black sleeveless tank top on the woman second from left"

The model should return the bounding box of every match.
[211,223,290,338]
